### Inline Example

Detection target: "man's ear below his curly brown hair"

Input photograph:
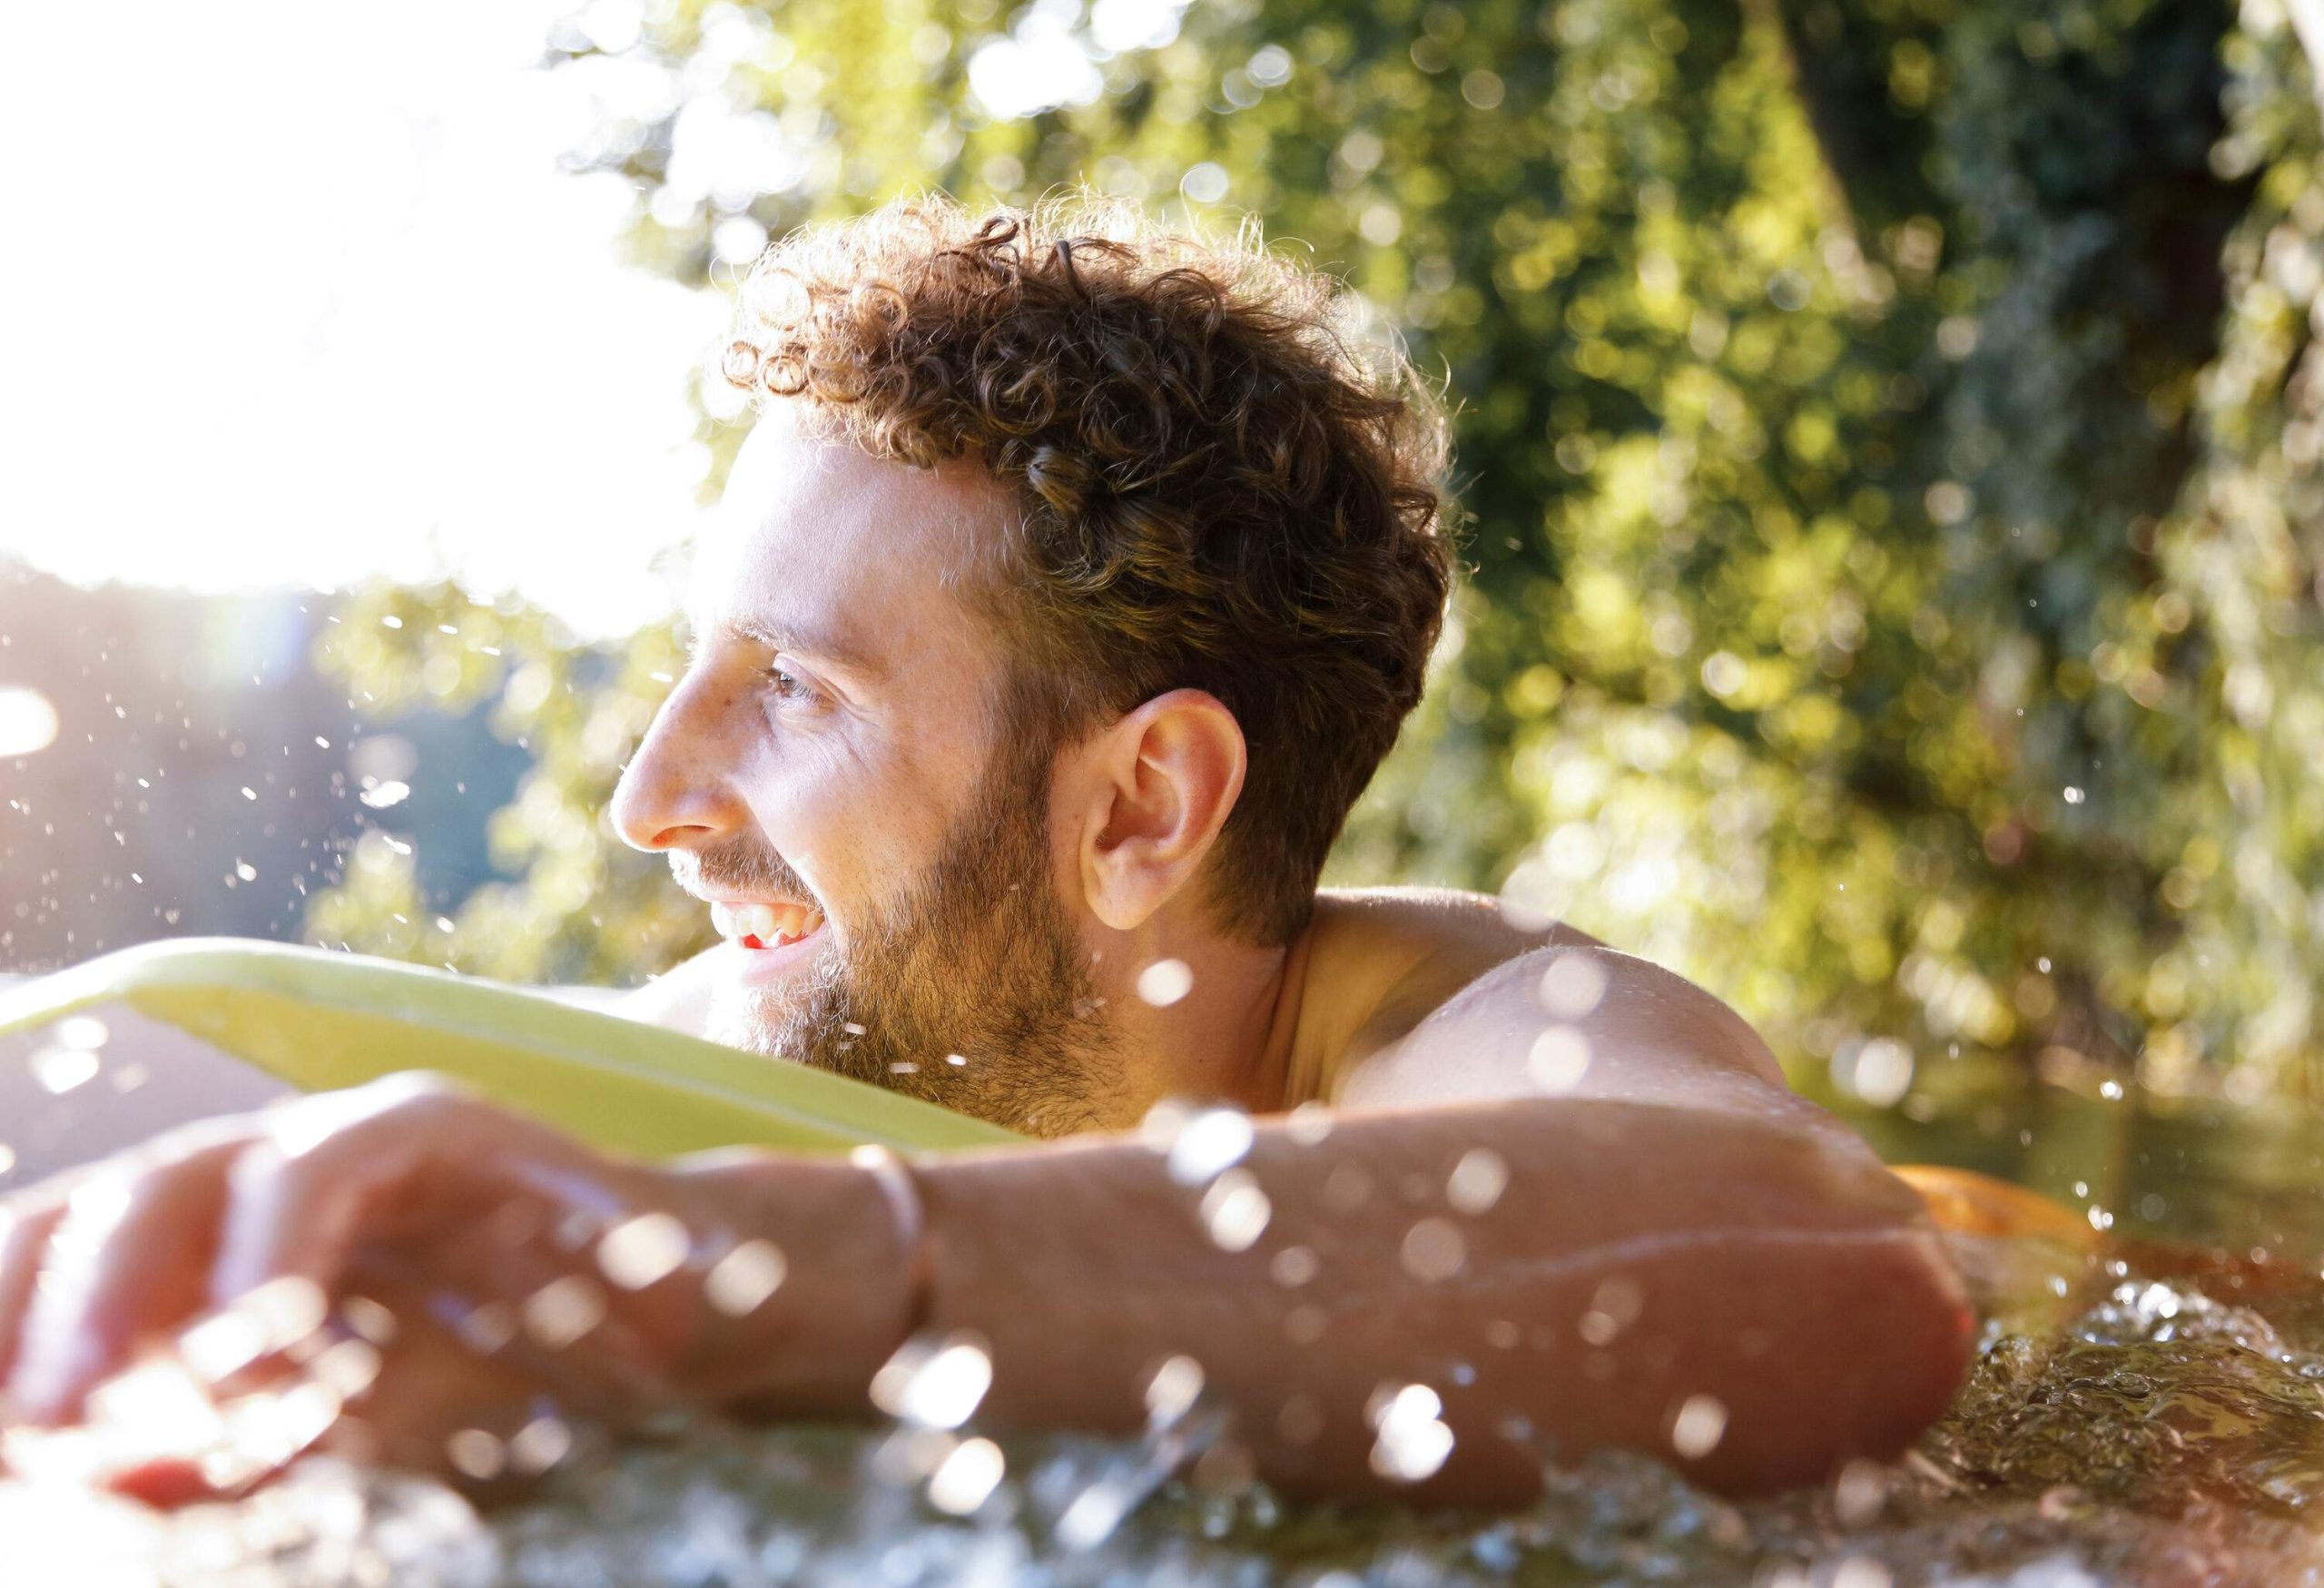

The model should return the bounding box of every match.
[1080,688,1250,932]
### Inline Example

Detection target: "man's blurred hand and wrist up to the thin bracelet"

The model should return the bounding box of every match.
[0,1077,901,1493]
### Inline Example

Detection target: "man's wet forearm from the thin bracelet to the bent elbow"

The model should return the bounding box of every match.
[697,1100,1971,1502]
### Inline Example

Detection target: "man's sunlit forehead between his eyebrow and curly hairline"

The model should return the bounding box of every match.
[685,416,1013,648]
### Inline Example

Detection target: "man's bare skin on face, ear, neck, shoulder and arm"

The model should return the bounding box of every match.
[0,416,1971,1504]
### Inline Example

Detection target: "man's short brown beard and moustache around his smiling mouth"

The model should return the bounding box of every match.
[700,746,1120,1135]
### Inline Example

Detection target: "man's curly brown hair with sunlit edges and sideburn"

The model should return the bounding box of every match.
[723,195,1450,944]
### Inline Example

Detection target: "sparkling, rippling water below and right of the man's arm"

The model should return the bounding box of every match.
[14,1093,2324,1588]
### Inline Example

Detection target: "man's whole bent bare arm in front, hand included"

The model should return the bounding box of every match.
[0,943,1971,1502]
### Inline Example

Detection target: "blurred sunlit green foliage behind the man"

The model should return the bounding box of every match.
[18,0,2324,1100]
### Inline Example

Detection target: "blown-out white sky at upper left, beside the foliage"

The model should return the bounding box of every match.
[0,0,725,633]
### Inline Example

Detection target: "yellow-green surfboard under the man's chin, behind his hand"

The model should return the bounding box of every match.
[0,937,1020,1168]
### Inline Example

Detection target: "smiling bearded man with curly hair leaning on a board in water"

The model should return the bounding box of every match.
[0,202,1971,1502]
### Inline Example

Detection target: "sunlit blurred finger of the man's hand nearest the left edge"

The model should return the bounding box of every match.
[7,1128,249,1421]
